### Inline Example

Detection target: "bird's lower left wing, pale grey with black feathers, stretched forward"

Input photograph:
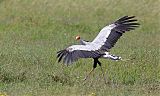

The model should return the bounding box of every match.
[57,45,104,64]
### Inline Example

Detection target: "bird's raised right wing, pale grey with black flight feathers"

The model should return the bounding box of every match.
[92,16,140,51]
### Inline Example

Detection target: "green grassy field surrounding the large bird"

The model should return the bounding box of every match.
[0,0,160,96]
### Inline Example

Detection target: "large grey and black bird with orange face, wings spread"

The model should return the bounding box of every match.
[57,16,140,83]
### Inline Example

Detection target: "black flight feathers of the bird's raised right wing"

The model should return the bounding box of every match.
[101,16,140,51]
